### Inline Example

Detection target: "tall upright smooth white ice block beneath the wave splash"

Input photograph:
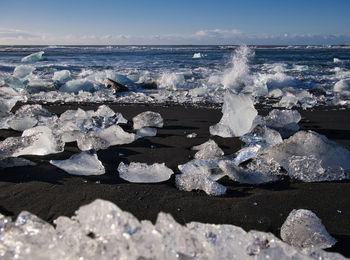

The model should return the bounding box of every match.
[209,91,258,137]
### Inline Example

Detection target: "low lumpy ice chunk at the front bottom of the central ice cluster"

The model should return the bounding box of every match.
[175,173,226,196]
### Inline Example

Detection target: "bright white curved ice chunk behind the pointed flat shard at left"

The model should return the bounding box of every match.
[12,126,64,157]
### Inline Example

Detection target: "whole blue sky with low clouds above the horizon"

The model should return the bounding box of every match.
[0,0,350,44]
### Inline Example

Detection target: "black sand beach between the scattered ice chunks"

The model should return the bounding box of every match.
[0,104,350,257]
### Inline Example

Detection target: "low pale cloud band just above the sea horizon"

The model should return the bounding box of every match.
[0,28,350,45]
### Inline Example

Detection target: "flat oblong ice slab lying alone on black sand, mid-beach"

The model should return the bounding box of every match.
[118,162,174,183]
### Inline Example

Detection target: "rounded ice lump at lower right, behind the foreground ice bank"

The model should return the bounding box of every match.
[281,209,337,251]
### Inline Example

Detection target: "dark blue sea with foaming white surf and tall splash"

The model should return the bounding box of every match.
[0,46,350,104]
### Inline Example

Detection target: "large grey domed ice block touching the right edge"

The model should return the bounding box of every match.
[261,131,350,182]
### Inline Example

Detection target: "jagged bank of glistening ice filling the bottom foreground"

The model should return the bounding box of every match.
[0,199,345,260]
